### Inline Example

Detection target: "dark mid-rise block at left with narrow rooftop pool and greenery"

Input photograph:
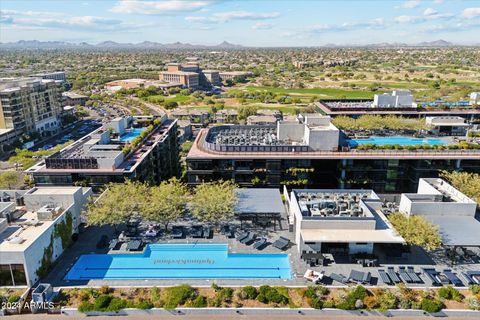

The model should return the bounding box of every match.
[25,115,180,187]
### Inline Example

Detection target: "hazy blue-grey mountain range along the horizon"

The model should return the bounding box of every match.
[0,40,480,50]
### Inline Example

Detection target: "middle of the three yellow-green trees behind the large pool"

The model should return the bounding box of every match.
[141,178,188,230]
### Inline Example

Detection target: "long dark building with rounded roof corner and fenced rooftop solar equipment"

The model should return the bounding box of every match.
[187,115,480,193]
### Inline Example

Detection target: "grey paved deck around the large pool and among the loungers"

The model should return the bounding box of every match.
[42,216,480,288]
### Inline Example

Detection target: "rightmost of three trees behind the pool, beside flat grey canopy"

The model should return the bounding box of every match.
[191,180,237,226]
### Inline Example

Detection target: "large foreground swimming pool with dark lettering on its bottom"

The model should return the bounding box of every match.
[65,244,291,280]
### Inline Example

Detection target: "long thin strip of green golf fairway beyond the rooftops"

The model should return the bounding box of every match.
[246,86,375,99]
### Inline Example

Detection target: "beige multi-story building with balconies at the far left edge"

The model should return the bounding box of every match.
[0,78,63,145]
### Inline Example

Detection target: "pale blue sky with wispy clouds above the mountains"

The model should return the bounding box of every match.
[0,0,480,46]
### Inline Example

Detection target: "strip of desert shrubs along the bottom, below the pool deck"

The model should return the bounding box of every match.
[57,284,480,313]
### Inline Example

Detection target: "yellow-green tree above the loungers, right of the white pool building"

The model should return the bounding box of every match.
[389,212,442,250]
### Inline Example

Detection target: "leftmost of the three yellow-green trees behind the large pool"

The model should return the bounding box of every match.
[86,180,148,230]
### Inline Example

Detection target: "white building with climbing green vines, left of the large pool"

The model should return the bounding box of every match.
[0,187,92,287]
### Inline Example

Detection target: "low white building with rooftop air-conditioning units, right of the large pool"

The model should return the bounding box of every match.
[284,189,405,256]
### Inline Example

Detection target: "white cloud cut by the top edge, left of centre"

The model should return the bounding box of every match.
[111,0,212,15]
